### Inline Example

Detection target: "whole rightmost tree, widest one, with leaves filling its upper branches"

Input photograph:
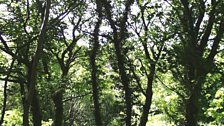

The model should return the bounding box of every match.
[168,0,223,126]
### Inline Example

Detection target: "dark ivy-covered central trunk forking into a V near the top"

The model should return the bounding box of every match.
[103,0,134,126]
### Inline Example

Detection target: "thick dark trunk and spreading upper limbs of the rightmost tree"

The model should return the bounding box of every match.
[177,0,224,126]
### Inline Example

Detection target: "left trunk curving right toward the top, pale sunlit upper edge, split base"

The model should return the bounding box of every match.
[24,0,51,126]
